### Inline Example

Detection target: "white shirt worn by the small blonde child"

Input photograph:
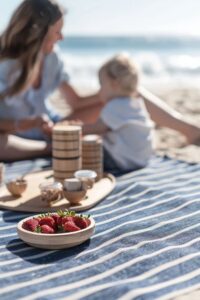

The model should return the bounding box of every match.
[100,97,153,170]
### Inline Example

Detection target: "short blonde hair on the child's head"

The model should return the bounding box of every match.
[99,54,139,94]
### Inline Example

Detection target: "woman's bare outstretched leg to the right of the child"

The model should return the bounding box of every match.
[139,87,200,143]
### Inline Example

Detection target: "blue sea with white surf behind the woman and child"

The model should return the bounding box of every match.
[60,36,200,89]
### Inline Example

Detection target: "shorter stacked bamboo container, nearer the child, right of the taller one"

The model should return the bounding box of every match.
[82,135,103,180]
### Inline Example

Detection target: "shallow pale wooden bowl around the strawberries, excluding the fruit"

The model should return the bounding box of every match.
[17,215,95,250]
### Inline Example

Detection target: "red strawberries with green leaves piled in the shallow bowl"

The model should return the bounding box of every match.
[22,210,90,234]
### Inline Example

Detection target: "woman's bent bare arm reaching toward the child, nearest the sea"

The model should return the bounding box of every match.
[59,82,101,111]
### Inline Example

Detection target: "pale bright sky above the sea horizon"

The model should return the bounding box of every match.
[0,0,200,37]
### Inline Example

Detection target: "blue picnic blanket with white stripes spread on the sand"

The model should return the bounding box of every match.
[0,158,200,300]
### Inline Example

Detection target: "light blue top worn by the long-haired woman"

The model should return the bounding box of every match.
[0,50,69,139]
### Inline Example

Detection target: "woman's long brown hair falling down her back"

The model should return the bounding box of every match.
[0,0,64,99]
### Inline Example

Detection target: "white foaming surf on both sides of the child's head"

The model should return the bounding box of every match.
[63,51,200,89]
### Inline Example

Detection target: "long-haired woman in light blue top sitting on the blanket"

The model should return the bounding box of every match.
[0,0,200,160]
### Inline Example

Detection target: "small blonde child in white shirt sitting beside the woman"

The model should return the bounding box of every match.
[78,55,153,172]
